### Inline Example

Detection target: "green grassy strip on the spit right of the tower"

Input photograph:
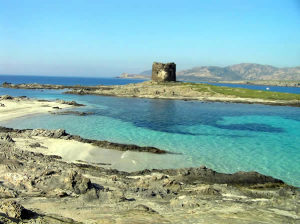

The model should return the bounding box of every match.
[181,83,300,100]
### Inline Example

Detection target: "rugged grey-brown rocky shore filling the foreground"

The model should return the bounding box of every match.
[0,127,300,223]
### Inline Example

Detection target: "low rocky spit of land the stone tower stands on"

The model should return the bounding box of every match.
[2,81,300,107]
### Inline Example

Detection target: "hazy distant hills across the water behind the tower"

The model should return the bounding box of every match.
[120,63,300,81]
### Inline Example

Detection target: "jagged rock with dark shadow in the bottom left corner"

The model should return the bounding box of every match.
[0,201,33,219]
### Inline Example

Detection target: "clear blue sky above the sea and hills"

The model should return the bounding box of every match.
[0,0,300,77]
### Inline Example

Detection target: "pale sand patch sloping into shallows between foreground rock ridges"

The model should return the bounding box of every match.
[14,137,182,172]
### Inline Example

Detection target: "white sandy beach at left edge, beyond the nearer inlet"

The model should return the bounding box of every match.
[0,99,72,122]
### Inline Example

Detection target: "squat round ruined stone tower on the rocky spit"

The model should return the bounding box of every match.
[152,62,176,82]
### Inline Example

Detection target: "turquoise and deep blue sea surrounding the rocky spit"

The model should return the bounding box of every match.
[0,75,300,187]
